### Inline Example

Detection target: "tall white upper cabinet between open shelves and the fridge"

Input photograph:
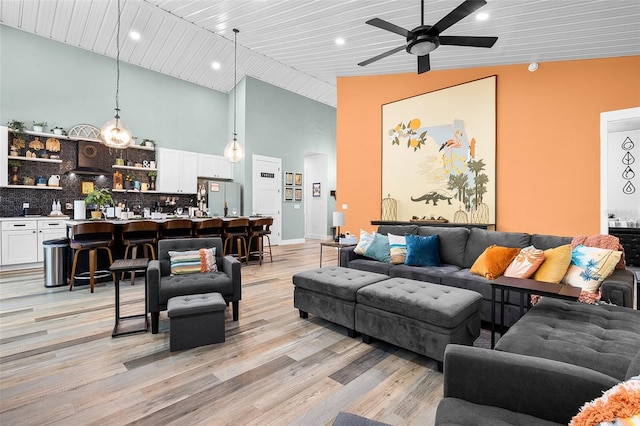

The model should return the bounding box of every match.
[156,148,198,194]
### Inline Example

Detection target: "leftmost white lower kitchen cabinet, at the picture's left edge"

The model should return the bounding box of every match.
[2,220,40,266]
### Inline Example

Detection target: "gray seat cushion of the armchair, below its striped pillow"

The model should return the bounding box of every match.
[159,271,233,305]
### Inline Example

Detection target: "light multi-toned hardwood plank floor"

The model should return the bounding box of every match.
[0,240,442,425]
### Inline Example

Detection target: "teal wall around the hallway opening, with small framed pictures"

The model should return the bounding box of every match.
[240,77,336,240]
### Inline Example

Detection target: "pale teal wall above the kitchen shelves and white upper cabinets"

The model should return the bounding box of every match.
[0,25,231,155]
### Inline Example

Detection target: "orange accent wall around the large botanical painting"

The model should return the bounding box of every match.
[336,56,640,236]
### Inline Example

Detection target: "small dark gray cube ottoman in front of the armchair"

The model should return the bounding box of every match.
[167,293,227,351]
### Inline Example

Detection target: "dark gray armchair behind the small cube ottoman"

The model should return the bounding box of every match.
[147,237,242,334]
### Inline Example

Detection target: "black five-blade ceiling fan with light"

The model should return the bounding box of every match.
[358,0,498,74]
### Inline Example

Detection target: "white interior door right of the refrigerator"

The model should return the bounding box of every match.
[254,155,282,245]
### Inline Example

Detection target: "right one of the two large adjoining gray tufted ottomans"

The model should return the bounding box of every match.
[356,278,482,369]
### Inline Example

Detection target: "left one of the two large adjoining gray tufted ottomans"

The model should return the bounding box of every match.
[293,266,389,337]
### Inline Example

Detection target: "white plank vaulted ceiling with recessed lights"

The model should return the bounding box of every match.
[0,0,640,106]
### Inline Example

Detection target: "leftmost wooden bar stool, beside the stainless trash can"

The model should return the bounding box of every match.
[69,222,116,293]
